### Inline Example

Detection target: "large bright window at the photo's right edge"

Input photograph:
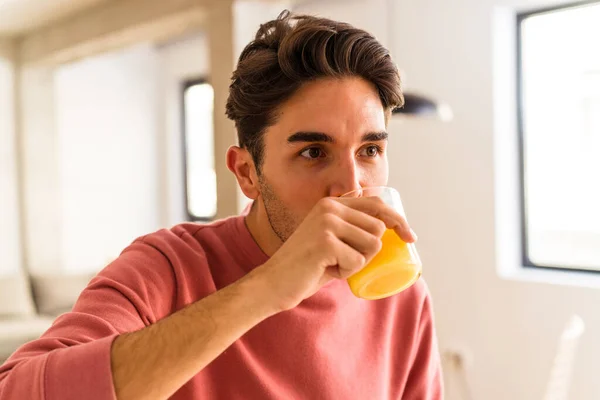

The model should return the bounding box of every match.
[517,1,600,271]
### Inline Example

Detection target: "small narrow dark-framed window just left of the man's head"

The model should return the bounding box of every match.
[183,80,217,221]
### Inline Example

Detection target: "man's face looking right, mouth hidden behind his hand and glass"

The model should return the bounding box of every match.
[259,78,388,241]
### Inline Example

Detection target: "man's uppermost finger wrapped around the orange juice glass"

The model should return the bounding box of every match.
[336,197,417,243]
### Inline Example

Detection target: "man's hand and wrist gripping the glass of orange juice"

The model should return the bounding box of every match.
[255,197,416,311]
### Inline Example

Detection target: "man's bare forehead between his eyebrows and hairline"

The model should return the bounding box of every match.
[267,77,386,141]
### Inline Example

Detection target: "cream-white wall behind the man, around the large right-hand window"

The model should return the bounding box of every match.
[296,0,600,400]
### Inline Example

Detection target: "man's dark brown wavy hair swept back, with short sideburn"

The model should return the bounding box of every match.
[226,10,404,173]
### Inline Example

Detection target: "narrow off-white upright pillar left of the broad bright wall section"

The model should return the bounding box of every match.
[18,66,62,274]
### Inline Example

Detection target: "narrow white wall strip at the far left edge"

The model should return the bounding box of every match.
[0,43,21,275]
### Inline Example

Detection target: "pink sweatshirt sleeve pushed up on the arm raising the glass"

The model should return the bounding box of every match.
[0,240,175,400]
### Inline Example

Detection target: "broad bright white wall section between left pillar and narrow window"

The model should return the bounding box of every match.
[55,45,160,272]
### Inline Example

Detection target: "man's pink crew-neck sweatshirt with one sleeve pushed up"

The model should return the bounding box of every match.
[0,217,442,400]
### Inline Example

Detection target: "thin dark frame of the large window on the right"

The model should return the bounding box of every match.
[516,0,600,275]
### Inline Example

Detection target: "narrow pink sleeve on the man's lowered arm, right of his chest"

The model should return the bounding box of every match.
[402,284,444,400]
